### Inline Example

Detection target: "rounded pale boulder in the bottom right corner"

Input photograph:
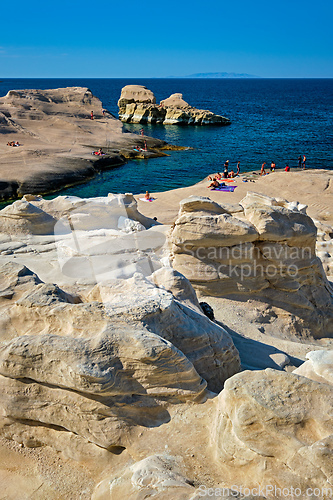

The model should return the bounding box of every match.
[211,369,333,499]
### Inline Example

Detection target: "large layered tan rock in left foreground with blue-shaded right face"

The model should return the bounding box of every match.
[0,264,239,449]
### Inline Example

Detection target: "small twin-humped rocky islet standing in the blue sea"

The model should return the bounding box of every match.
[118,85,230,125]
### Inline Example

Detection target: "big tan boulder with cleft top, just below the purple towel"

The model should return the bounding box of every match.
[170,193,333,337]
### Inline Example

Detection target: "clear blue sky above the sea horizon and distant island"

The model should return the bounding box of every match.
[0,0,333,79]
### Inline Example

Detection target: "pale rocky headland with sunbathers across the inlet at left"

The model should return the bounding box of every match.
[0,87,175,201]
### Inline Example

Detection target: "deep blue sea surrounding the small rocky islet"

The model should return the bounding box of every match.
[0,78,333,197]
